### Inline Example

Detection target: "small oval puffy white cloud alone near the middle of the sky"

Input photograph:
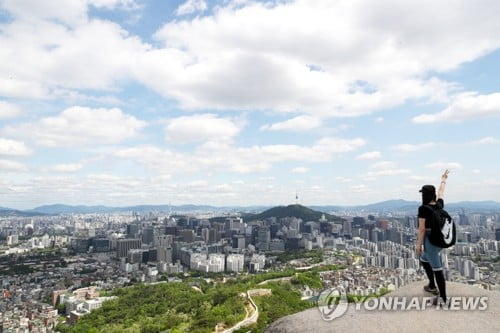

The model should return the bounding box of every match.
[165,114,240,143]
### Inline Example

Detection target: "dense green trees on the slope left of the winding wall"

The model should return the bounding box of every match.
[57,283,245,333]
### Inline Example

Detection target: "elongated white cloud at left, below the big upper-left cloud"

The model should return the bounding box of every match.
[3,106,146,147]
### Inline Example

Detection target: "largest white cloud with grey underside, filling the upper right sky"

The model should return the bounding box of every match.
[150,1,500,117]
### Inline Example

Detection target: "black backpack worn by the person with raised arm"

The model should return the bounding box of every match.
[429,206,457,248]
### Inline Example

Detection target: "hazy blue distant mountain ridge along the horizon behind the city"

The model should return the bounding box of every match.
[0,199,500,216]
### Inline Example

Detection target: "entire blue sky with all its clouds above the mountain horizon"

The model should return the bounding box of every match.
[0,0,500,208]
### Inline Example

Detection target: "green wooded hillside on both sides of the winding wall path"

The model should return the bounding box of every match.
[53,256,348,333]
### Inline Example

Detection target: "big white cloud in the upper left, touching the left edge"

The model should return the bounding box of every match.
[0,17,149,99]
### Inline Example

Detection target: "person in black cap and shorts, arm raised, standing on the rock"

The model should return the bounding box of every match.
[417,169,449,305]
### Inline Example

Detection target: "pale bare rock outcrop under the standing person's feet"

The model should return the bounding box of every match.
[265,282,500,333]
